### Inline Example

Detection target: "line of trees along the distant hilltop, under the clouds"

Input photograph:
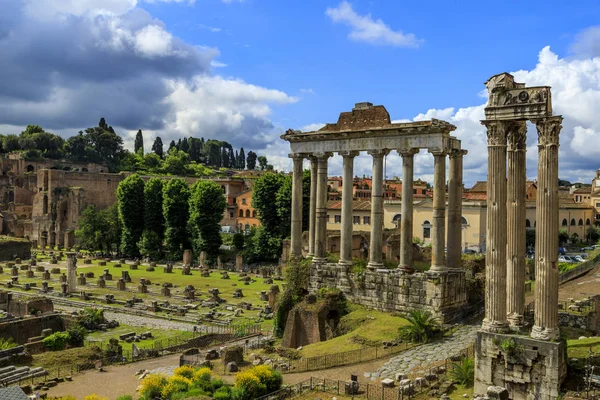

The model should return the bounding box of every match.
[0,118,273,175]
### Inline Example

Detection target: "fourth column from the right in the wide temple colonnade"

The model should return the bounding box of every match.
[367,150,389,270]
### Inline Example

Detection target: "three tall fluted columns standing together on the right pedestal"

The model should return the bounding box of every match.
[482,116,562,340]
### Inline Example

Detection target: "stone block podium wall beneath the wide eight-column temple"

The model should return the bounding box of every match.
[309,263,467,323]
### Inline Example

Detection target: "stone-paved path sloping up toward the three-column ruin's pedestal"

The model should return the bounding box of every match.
[365,324,480,379]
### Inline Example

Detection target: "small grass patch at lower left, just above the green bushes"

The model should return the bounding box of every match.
[86,324,197,349]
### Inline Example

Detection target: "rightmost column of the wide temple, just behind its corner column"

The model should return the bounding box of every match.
[447,150,467,268]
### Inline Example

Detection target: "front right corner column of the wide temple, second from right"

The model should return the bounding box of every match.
[430,150,448,272]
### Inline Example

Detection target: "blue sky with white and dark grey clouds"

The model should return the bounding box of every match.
[0,0,600,183]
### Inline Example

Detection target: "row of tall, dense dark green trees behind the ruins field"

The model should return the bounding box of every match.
[75,174,227,260]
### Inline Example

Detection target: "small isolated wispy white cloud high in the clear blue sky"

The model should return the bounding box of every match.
[325,0,423,47]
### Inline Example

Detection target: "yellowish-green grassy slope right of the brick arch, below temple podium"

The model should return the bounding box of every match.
[301,304,408,357]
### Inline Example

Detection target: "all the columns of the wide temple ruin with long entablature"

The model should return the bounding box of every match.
[291,149,466,272]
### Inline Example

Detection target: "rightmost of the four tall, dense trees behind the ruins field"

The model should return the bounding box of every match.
[190,180,227,260]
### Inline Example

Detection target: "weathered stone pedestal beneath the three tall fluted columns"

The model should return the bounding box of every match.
[475,331,567,400]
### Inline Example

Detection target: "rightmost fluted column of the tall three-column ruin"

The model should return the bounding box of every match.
[531,116,562,340]
